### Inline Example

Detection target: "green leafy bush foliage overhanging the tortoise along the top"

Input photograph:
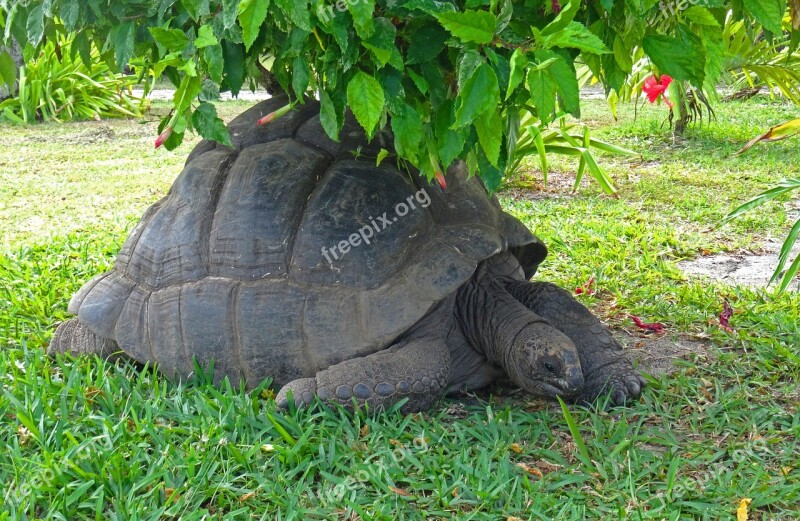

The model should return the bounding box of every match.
[0,0,800,188]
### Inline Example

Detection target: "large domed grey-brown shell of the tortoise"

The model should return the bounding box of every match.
[69,97,546,386]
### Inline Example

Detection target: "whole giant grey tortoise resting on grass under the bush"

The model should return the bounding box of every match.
[48,97,644,411]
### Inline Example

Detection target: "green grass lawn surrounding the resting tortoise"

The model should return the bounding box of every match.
[0,98,800,520]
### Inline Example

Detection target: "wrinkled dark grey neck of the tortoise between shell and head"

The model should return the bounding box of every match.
[455,262,544,374]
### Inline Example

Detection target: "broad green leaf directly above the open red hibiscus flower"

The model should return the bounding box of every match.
[642,24,706,87]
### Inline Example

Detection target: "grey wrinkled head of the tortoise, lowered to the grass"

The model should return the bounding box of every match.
[503,321,583,397]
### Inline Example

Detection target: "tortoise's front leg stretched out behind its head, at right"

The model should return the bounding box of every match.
[505,279,645,405]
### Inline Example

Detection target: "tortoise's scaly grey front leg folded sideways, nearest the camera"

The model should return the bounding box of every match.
[275,338,450,412]
